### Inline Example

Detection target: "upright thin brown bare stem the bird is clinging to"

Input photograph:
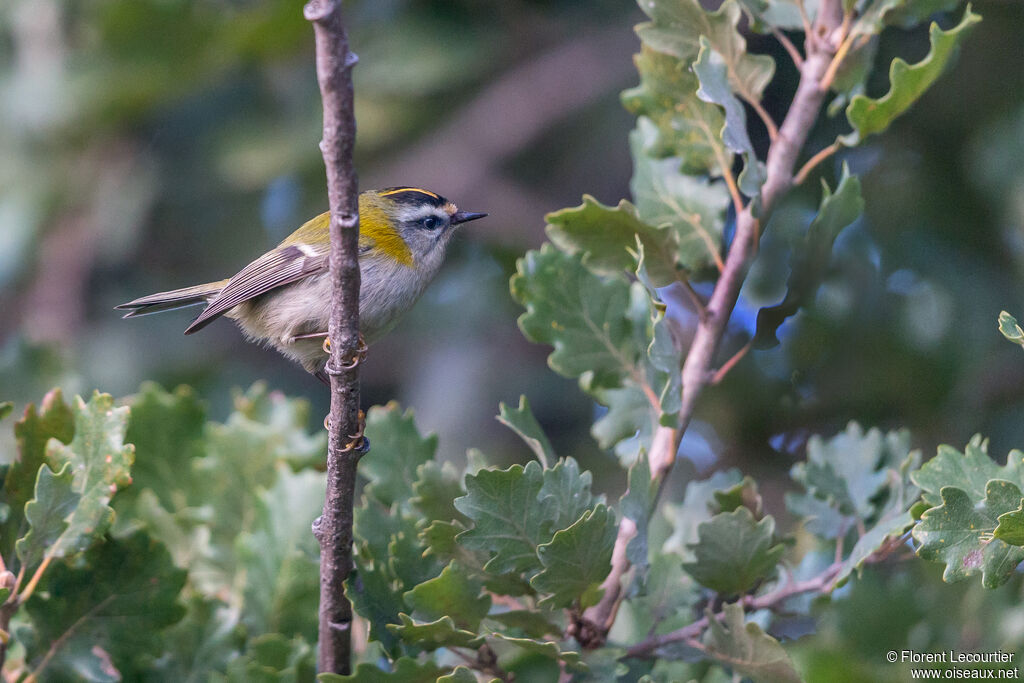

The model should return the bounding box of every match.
[303,0,359,674]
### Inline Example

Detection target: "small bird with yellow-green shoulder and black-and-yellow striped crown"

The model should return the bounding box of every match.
[117,187,487,383]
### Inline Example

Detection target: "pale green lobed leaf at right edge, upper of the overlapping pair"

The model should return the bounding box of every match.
[910,435,1024,507]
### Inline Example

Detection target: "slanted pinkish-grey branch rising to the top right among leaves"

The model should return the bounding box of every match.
[578,0,843,647]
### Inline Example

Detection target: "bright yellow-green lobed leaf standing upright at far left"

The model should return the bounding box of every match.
[18,392,134,562]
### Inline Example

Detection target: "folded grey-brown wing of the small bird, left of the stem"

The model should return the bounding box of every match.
[185,245,328,335]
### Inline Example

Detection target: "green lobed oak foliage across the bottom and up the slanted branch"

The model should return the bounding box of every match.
[0,0,1024,681]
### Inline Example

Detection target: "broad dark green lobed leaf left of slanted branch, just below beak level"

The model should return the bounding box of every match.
[511,245,646,390]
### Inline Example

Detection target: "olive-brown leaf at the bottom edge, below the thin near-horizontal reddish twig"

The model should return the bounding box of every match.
[707,604,803,683]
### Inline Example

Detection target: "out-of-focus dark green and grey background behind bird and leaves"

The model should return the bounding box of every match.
[0,0,1024,680]
